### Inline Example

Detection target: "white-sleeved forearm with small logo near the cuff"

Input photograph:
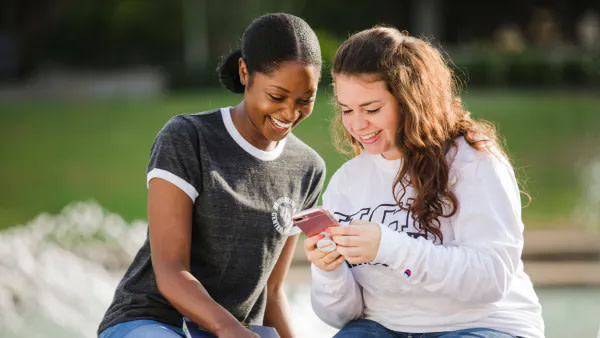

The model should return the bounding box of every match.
[375,226,521,304]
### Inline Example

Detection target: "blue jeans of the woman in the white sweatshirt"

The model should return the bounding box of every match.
[334,319,515,338]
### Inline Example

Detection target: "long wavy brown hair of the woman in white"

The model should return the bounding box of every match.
[331,26,508,243]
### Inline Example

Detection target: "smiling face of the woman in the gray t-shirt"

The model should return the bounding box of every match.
[240,60,320,150]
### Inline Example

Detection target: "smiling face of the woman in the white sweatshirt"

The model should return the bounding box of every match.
[335,75,400,160]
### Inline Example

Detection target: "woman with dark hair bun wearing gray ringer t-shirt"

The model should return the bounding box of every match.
[98,13,325,338]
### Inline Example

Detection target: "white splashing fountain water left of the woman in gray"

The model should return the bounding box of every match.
[0,202,146,338]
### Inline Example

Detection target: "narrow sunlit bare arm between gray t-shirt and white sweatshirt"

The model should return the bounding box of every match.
[264,235,299,338]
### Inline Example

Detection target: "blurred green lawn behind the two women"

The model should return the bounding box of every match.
[0,89,600,228]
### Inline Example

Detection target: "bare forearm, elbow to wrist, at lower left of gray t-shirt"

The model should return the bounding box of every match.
[157,269,241,335]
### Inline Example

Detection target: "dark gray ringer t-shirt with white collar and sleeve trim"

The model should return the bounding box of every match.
[98,108,325,332]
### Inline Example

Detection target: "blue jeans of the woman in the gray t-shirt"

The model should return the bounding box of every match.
[98,319,185,338]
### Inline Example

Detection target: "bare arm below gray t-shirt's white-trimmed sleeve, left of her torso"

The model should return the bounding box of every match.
[148,178,255,337]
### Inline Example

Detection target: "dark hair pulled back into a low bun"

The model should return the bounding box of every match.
[217,13,322,93]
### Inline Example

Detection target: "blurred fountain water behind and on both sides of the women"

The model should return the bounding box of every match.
[0,202,600,338]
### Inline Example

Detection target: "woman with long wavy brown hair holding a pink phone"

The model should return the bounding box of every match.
[304,27,544,337]
